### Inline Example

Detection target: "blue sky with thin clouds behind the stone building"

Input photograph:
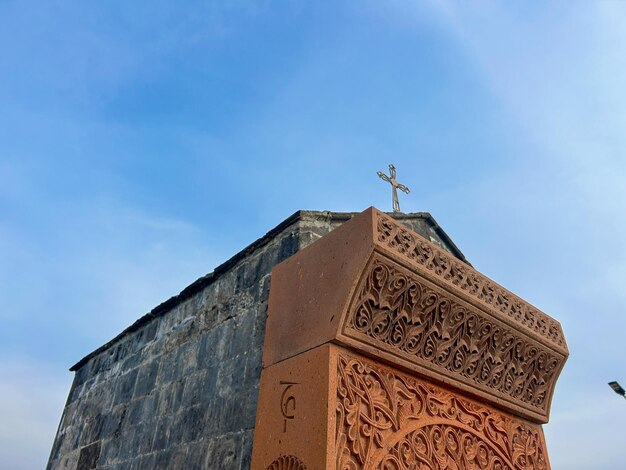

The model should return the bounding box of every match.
[0,0,626,470]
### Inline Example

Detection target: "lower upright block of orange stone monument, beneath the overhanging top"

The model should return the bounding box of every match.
[252,345,549,470]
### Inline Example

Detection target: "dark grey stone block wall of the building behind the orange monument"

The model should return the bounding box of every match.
[48,212,464,470]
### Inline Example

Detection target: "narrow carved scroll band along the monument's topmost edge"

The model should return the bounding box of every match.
[378,215,566,350]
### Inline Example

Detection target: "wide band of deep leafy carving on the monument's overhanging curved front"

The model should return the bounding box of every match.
[345,259,563,412]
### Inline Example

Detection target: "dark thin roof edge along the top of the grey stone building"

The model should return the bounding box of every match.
[69,210,464,372]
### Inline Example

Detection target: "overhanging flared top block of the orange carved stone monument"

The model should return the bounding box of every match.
[263,208,568,424]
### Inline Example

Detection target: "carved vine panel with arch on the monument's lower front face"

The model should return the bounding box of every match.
[335,355,549,470]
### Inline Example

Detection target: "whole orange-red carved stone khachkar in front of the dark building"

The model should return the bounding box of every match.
[252,208,568,470]
